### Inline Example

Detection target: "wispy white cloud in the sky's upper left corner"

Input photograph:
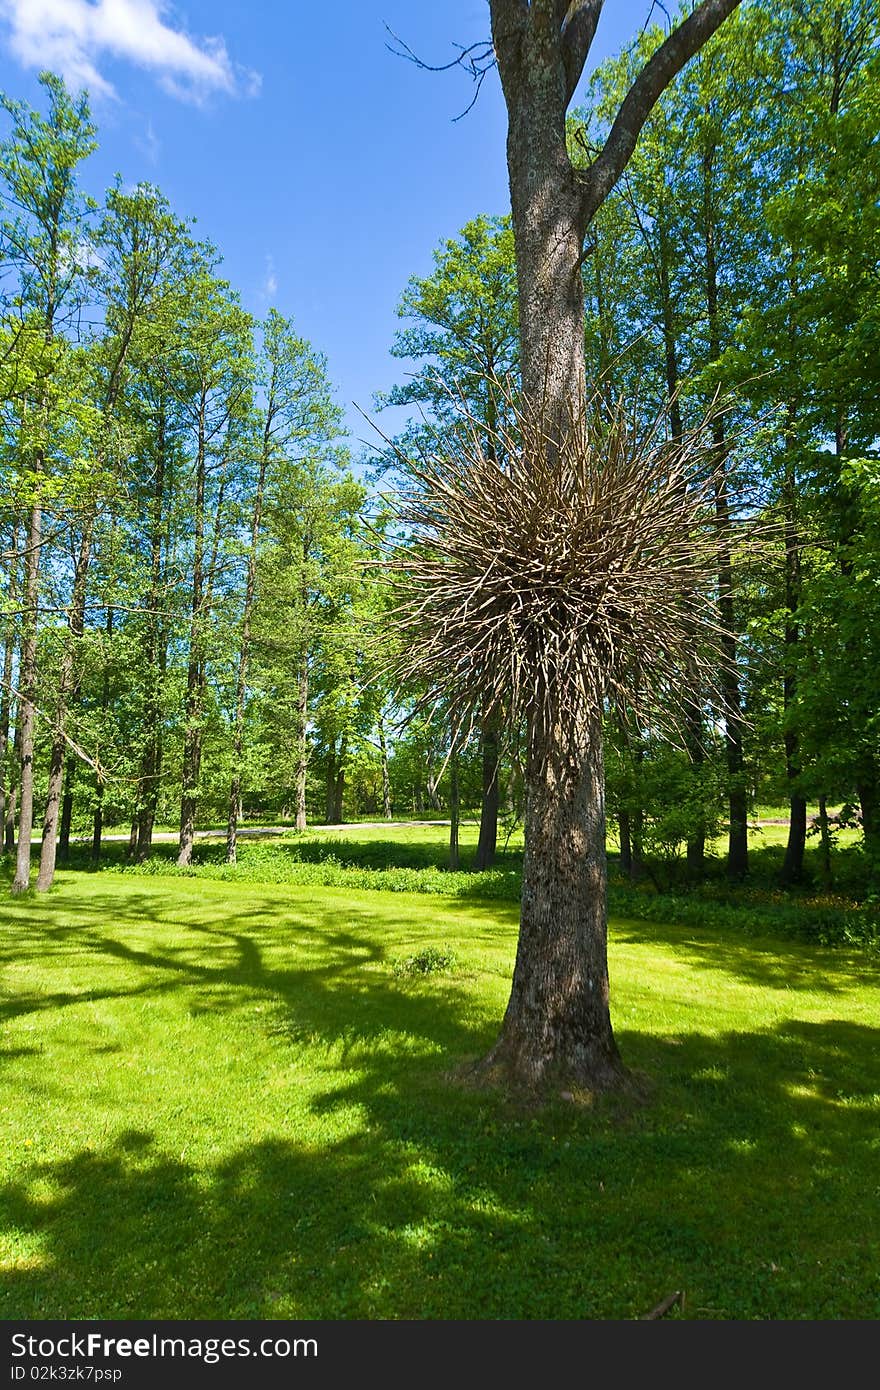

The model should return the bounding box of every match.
[0,0,259,103]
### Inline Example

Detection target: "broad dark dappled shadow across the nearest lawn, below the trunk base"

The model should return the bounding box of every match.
[0,1023,880,1319]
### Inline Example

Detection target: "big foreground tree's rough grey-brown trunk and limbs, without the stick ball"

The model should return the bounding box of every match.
[488,0,738,1090]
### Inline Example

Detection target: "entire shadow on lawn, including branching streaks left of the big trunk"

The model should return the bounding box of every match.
[0,899,880,1319]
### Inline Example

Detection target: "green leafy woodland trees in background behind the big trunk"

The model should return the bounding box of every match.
[0,0,880,906]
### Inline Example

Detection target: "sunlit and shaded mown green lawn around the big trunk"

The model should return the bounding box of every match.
[0,873,880,1319]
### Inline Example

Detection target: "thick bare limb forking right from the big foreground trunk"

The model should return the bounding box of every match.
[580,0,740,231]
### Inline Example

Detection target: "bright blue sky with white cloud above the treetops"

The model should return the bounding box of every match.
[0,0,651,447]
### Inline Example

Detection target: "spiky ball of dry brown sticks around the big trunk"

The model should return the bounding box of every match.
[388,395,739,745]
